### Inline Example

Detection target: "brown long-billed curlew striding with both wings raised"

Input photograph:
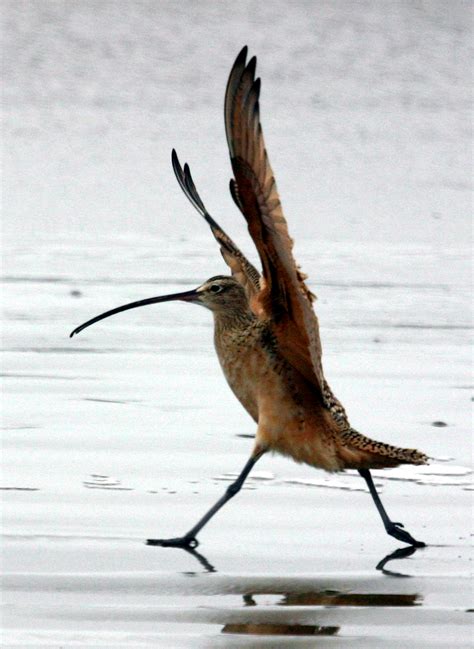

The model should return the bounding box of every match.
[71,47,428,549]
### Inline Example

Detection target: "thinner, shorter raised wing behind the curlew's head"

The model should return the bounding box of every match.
[171,149,260,302]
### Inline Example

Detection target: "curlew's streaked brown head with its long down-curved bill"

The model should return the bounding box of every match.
[70,275,250,338]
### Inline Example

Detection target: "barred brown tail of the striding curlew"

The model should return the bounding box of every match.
[339,428,428,469]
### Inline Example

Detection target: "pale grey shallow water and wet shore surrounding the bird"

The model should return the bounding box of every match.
[0,1,473,649]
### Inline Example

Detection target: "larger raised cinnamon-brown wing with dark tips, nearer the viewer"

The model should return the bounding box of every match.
[224,47,326,394]
